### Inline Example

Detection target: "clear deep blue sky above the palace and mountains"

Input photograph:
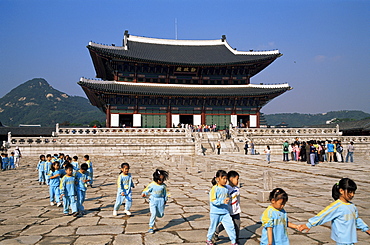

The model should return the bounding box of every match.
[0,0,370,114]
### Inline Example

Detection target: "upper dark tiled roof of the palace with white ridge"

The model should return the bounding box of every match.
[87,35,281,65]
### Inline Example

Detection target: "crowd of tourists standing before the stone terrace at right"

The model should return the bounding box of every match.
[283,139,355,166]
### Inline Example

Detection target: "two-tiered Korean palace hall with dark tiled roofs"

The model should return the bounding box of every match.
[78,31,291,129]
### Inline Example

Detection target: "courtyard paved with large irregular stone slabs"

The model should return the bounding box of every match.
[0,154,370,245]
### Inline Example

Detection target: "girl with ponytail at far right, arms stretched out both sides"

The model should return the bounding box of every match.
[300,178,370,244]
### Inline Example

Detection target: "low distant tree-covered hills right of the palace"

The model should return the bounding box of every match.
[264,110,370,127]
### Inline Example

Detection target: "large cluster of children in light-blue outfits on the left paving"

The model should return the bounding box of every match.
[36,153,93,216]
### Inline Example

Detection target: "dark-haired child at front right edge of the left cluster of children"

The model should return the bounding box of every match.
[76,163,90,215]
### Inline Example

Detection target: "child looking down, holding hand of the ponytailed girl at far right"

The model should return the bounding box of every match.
[261,188,298,245]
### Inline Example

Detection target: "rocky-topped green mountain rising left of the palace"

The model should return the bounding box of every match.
[0,78,105,127]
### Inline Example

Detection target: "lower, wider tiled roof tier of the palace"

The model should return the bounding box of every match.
[78,78,291,97]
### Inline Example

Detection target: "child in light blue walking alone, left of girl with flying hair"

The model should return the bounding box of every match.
[113,162,135,216]
